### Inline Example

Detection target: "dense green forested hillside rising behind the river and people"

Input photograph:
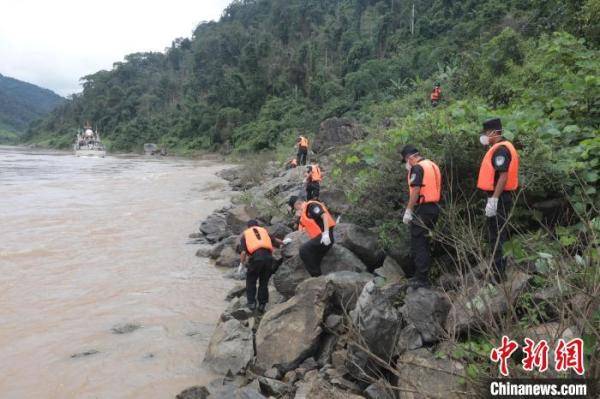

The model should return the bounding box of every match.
[22,0,600,151]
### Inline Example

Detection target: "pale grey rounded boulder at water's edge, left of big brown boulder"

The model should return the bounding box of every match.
[203,318,254,374]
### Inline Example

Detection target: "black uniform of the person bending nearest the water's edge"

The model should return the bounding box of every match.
[240,234,273,305]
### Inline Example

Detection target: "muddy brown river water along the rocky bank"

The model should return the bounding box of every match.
[0,147,232,399]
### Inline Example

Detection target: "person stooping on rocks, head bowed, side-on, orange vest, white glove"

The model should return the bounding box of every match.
[288,196,335,277]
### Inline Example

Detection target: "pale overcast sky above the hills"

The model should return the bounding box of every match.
[0,0,232,96]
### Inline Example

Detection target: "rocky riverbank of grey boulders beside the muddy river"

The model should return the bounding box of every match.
[177,119,598,399]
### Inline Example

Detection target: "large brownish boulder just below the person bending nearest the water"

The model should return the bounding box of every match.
[256,278,332,373]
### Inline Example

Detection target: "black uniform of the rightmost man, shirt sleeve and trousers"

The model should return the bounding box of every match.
[487,146,513,276]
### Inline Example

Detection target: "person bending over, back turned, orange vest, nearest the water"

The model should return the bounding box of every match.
[239,220,288,312]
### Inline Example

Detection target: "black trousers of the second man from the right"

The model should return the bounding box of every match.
[410,204,440,282]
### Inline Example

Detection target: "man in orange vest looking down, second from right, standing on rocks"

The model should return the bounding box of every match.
[401,144,442,288]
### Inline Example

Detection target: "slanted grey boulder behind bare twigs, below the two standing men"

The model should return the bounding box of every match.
[446,270,531,334]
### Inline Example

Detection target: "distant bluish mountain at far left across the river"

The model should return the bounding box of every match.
[0,74,65,136]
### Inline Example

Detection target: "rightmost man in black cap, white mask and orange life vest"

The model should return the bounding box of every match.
[477,118,519,282]
